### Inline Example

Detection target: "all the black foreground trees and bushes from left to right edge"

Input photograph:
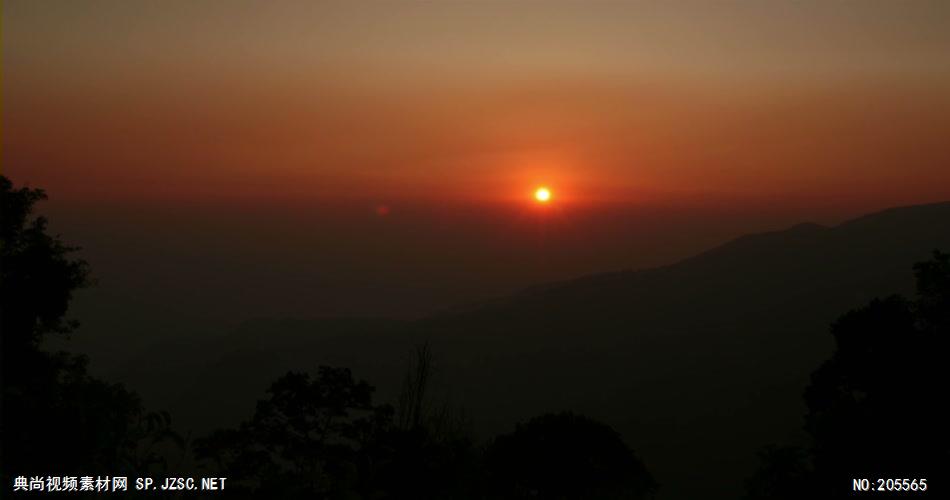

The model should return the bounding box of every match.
[0,178,950,499]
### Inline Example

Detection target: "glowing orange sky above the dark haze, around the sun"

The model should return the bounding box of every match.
[2,1,950,207]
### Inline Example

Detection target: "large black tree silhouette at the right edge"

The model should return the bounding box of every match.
[748,251,950,498]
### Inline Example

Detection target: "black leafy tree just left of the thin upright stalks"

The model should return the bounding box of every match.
[195,367,393,498]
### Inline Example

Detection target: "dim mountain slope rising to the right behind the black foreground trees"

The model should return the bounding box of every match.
[115,203,950,498]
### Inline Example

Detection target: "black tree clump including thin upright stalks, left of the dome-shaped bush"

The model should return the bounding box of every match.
[195,347,477,499]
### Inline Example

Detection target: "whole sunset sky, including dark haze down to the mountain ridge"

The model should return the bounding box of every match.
[2,0,950,324]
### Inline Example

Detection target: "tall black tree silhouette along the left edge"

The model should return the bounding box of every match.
[0,176,178,481]
